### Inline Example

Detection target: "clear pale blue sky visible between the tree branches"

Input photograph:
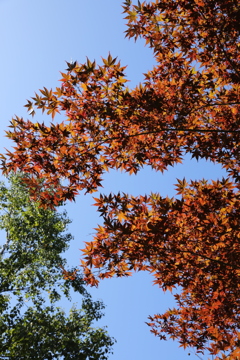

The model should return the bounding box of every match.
[0,0,225,360]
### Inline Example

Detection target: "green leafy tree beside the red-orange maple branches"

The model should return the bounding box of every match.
[0,175,113,360]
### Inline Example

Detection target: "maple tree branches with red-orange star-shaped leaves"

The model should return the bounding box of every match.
[2,0,240,359]
